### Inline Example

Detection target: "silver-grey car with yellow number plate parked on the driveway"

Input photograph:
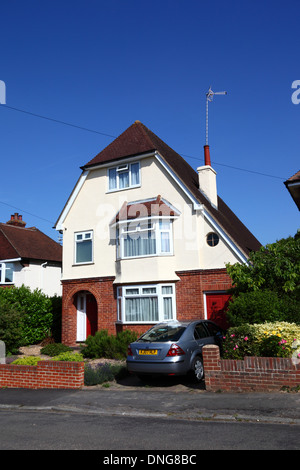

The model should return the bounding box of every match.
[126,320,225,382]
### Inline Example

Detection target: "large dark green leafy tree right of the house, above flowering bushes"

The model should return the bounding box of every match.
[226,232,300,326]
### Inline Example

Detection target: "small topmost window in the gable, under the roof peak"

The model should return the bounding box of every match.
[108,162,140,191]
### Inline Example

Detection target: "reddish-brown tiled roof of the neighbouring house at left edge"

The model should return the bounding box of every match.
[0,223,62,263]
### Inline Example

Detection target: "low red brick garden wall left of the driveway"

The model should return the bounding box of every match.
[0,361,84,389]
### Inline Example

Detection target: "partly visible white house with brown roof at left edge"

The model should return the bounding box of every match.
[0,213,62,297]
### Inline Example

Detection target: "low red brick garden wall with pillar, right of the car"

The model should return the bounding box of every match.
[202,345,300,392]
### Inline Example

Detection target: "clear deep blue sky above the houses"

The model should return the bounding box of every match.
[0,0,300,245]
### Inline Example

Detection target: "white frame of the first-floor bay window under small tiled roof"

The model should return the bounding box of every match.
[116,217,174,259]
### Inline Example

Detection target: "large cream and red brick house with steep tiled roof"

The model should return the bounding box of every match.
[55,121,261,345]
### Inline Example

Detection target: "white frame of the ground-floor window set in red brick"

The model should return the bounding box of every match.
[117,283,176,325]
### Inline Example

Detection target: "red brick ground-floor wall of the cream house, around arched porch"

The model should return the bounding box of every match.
[62,269,232,346]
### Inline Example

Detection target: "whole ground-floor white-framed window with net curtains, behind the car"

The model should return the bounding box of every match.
[118,284,176,323]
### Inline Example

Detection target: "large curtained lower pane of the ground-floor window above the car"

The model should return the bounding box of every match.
[125,297,158,322]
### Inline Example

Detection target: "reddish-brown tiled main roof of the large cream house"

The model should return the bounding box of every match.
[82,121,261,255]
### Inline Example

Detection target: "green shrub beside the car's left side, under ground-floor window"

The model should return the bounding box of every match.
[82,330,137,359]
